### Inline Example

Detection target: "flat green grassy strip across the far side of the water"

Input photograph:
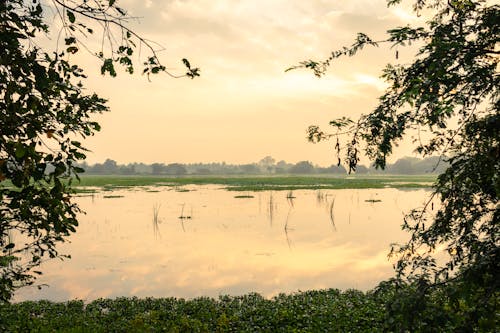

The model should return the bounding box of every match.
[74,175,435,191]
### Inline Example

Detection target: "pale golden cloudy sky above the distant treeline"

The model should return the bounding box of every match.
[44,0,426,166]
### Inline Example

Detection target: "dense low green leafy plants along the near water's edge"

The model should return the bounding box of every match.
[0,283,488,332]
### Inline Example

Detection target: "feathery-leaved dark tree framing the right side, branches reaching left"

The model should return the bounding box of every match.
[293,0,500,332]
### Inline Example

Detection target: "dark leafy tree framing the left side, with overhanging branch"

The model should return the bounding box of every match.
[0,0,199,302]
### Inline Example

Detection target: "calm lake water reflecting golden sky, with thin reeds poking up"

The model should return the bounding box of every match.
[15,186,429,301]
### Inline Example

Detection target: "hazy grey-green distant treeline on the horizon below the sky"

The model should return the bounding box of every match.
[79,156,446,176]
